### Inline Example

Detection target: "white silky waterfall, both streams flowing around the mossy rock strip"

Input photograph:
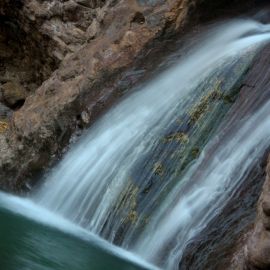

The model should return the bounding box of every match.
[32,17,270,269]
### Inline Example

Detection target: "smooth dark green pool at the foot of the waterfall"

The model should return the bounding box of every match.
[0,194,155,270]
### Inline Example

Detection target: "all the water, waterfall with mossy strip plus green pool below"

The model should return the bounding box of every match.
[0,16,270,270]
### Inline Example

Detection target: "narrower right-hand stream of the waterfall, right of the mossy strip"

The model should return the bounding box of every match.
[134,97,270,269]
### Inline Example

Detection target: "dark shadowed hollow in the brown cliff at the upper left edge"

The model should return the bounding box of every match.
[0,11,57,121]
